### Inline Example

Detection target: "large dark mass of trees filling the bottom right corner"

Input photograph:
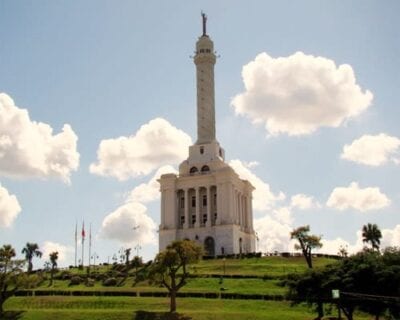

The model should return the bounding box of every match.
[285,247,400,320]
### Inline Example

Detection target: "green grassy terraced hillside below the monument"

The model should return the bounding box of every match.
[5,257,367,320]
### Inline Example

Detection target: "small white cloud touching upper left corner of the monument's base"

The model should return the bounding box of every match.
[127,166,177,203]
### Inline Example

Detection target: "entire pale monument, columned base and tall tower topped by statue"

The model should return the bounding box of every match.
[159,15,255,256]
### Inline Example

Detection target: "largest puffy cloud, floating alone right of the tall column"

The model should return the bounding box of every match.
[231,52,373,135]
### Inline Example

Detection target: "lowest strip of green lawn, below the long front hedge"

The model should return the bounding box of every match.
[5,296,368,320]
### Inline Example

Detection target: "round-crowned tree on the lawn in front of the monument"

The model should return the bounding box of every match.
[149,240,203,312]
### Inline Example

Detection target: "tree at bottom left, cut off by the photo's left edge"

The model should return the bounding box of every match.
[0,245,25,319]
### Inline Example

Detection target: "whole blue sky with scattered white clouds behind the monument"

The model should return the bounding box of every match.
[0,0,400,268]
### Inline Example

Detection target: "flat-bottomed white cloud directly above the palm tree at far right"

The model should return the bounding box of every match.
[326,182,390,211]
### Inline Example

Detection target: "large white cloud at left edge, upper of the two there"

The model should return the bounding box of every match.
[0,93,79,183]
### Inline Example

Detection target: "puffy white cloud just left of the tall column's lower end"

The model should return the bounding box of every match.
[90,118,192,180]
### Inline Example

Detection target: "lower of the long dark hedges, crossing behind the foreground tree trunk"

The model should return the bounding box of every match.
[15,290,285,301]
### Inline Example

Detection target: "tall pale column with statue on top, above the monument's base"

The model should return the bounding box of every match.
[194,13,216,144]
